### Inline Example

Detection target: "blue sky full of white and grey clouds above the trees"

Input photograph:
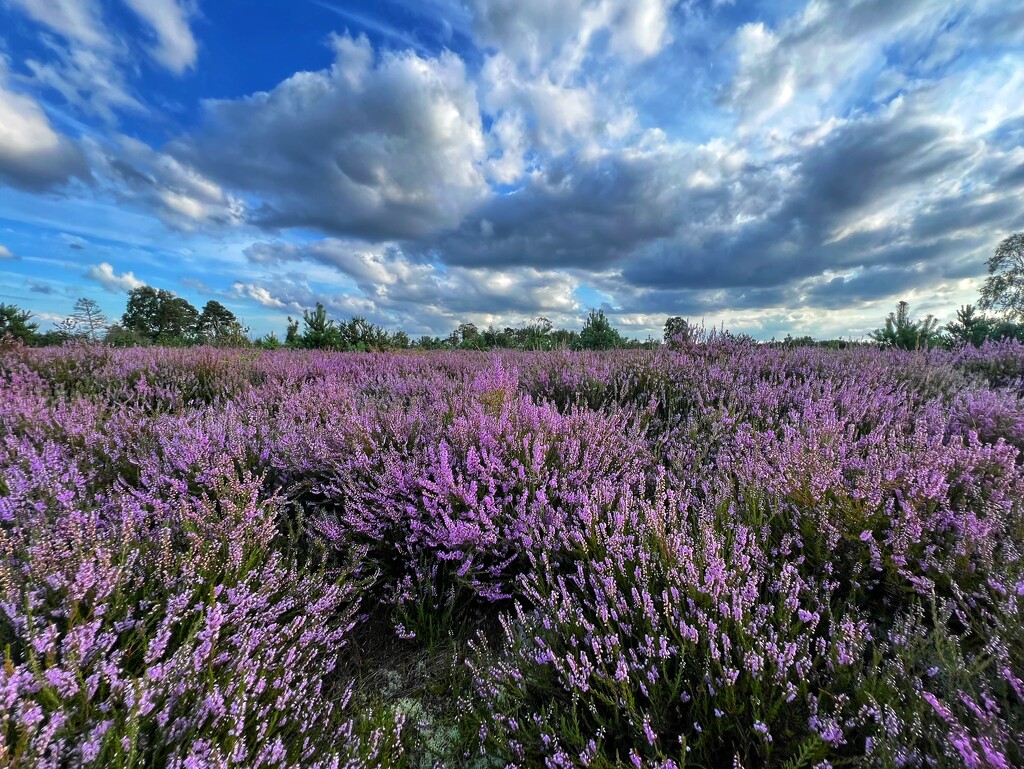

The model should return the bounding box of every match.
[0,0,1024,339]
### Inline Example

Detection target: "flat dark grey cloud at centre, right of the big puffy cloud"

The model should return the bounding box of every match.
[426,134,770,271]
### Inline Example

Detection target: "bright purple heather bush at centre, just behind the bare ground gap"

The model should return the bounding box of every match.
[313,366,645,643]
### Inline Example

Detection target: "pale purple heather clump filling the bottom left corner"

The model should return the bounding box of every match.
[0,439,400,767]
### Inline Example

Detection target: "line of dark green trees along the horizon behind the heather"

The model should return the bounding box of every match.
[6,232,1024,352]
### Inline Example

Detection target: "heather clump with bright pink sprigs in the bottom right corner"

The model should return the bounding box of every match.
[848,596,1024,769]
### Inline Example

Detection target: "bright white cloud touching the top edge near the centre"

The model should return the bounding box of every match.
[470,0,676,171]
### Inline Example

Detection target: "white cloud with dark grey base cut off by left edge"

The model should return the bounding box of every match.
[0,56,89,193]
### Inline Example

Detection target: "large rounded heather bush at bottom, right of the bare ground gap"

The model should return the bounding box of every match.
[475,489,870,767]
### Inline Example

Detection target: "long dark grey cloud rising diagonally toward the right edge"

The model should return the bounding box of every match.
[623,99,1015,290]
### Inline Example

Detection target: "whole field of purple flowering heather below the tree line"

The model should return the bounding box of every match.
[0,338,1024,769]
